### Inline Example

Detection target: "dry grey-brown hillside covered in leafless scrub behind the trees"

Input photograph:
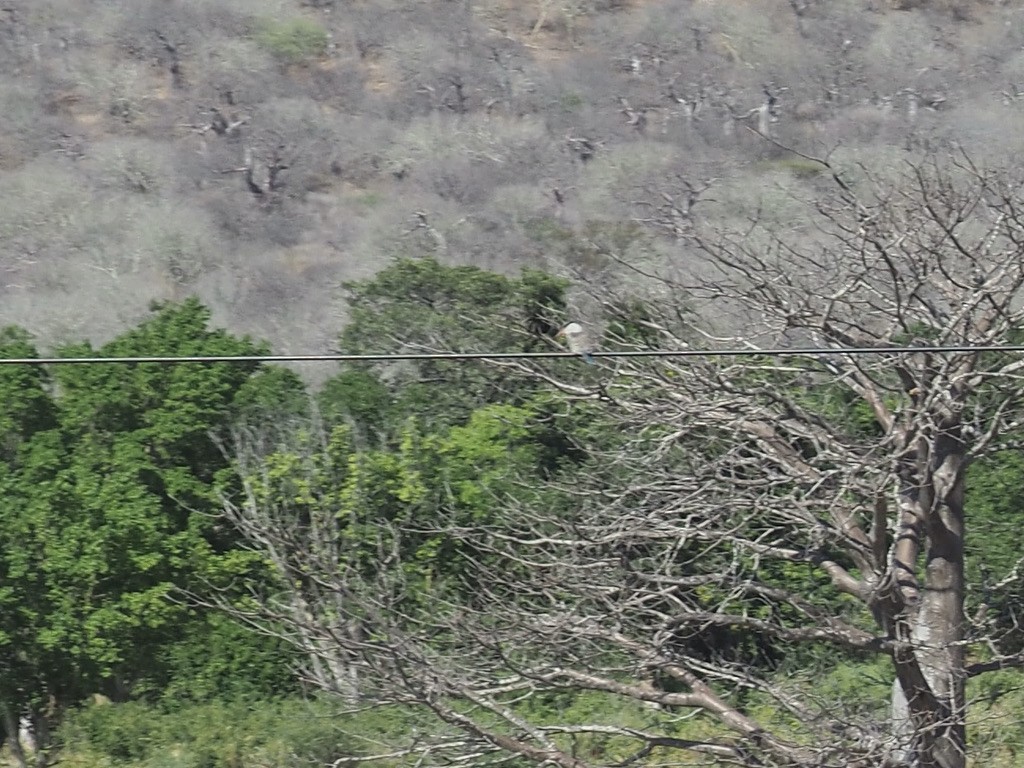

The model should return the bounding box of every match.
[0,0,1024,372]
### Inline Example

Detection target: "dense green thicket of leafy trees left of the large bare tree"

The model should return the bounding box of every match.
[0,261,571,759]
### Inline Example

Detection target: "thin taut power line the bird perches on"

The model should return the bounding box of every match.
[6,344,1024,366]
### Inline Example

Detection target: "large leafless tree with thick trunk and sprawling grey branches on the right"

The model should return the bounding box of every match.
[220,155,1024,768]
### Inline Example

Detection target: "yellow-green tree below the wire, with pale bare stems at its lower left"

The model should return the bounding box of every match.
[222,391,585,699]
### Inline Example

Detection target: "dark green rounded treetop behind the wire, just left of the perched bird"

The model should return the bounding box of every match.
[335,259,566,429]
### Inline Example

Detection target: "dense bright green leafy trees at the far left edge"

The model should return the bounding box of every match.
[0,300,296,733]
